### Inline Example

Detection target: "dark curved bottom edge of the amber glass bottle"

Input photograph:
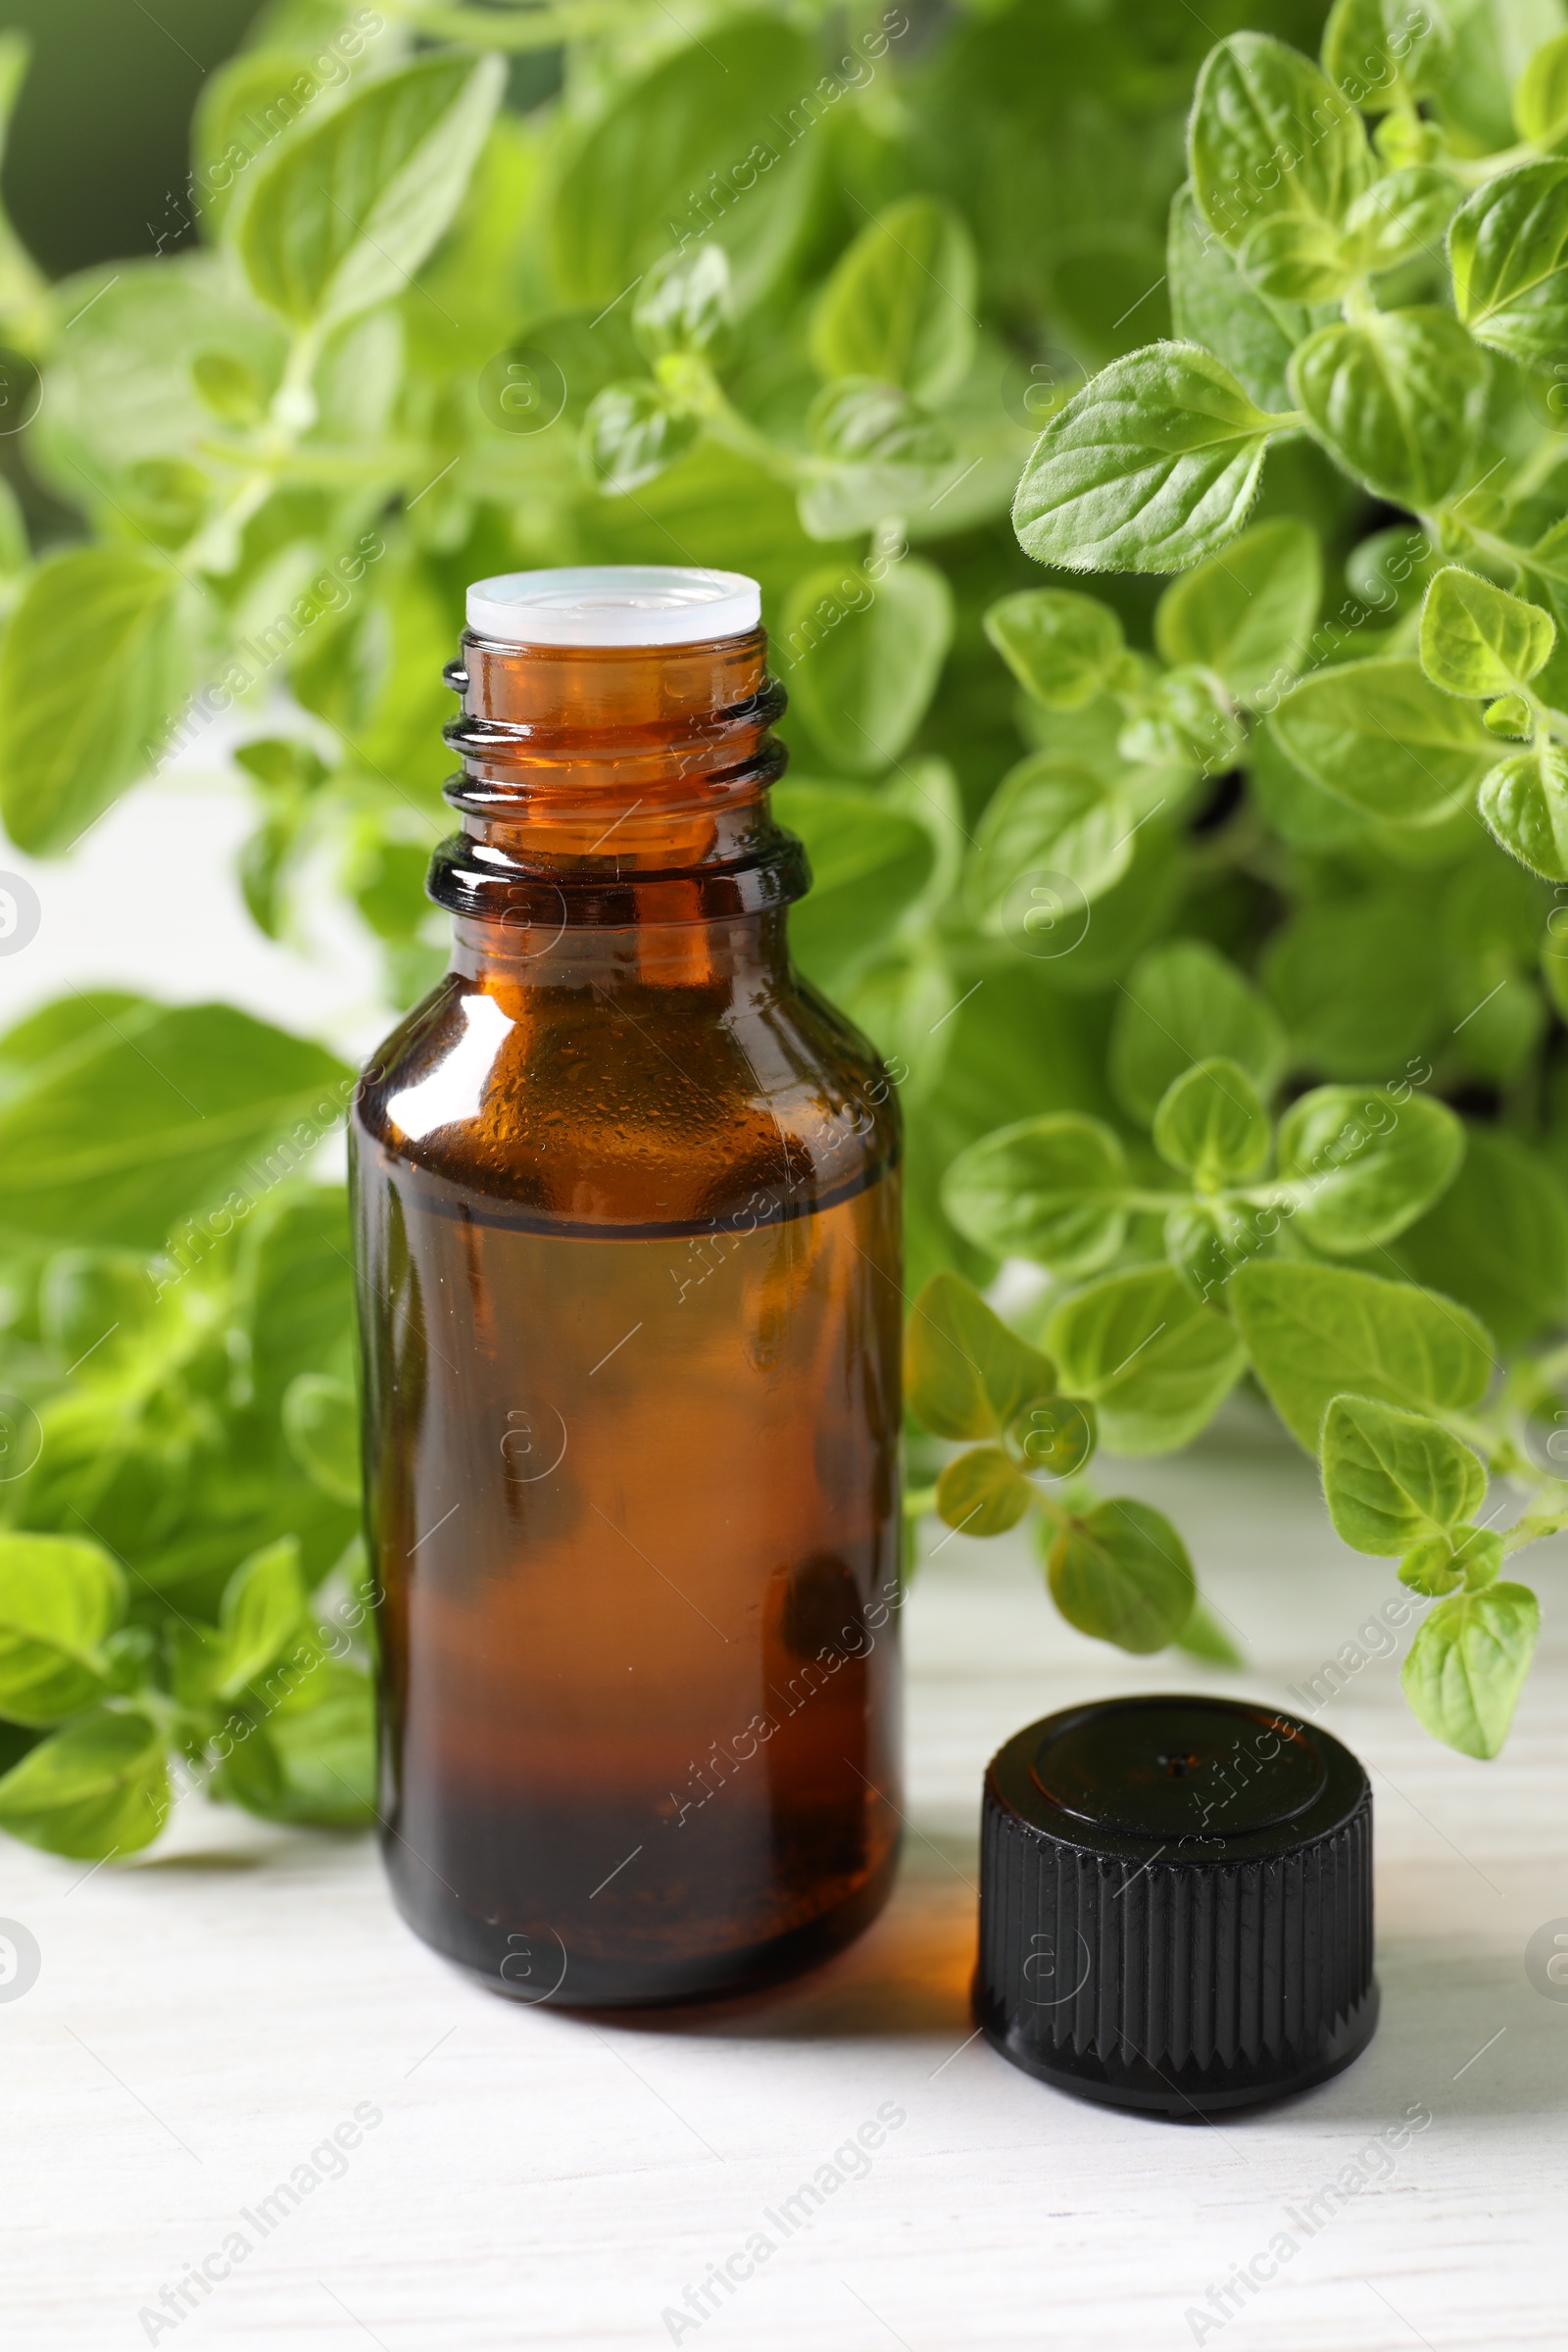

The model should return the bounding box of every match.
[388,1841,898,2009]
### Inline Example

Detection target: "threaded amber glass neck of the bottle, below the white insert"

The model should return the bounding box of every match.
[430,628,808,955]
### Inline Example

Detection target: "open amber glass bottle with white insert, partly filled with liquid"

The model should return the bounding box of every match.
[353,566,901,2004]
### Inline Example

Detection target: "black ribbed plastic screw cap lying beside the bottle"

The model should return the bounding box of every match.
[976,1695,1378,2115]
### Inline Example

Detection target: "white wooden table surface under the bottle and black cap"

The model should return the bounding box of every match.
[0,1416,1568,2352]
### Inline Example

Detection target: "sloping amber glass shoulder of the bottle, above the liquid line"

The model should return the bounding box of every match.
[355,971,901,1225]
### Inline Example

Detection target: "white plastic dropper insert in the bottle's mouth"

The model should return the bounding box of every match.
[467,564,761,645]
